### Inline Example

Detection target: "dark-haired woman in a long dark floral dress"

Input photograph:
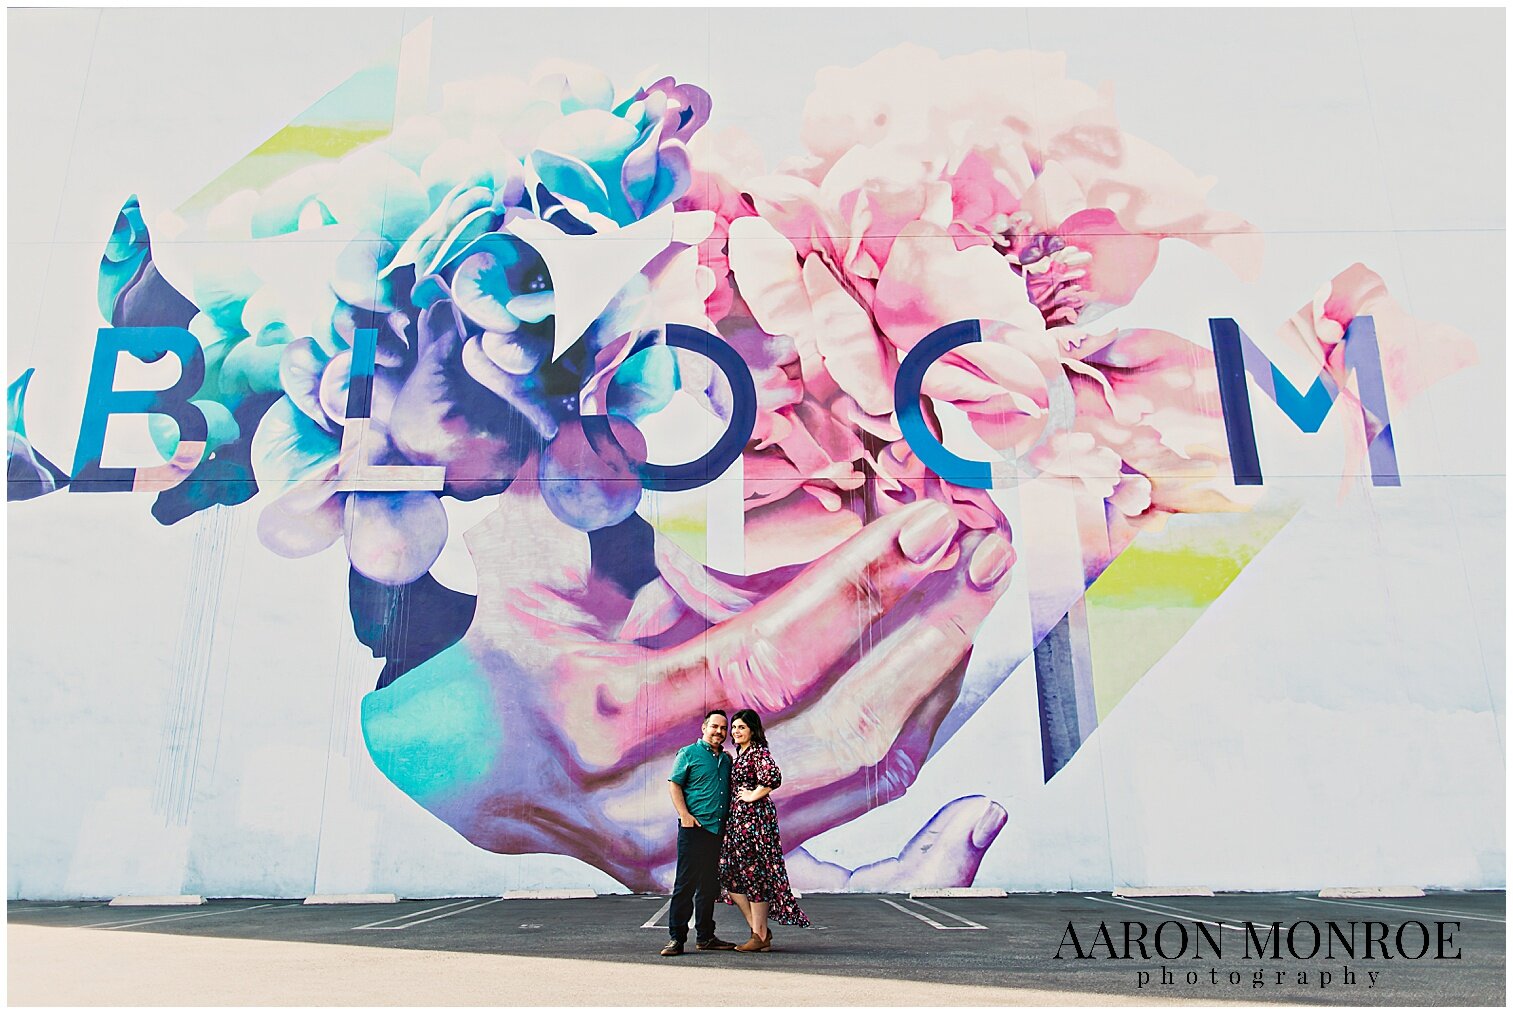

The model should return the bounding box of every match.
[720,708,809,952]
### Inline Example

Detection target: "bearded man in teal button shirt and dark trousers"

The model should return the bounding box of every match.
[661,708,735,958]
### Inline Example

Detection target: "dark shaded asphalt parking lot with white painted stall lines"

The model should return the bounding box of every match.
[8,891,1507,1006]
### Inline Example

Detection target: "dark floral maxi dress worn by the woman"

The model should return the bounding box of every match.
[720,746,809,926]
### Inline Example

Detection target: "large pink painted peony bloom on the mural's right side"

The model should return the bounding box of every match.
[695,45,1259,581]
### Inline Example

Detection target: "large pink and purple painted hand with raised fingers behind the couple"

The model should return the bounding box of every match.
[362,468,1014,890]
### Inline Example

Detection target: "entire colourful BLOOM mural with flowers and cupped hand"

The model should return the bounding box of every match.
[8,9,1500,890]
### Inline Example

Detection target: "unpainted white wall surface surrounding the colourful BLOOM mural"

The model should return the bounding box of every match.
[8,9,1505,899]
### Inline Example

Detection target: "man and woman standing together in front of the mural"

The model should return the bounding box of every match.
[661,708,809,958]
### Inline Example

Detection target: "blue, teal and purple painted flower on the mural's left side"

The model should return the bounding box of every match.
[84,65,729,584]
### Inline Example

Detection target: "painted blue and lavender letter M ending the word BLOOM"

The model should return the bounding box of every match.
[1209,316,1403,486]
